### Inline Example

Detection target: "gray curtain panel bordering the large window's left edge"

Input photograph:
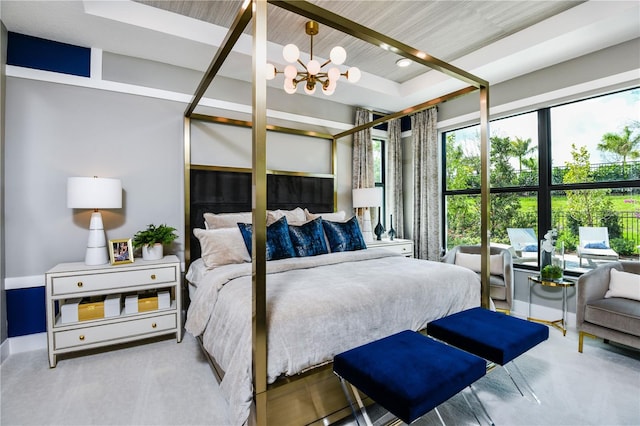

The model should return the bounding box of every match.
[411,108,441,261]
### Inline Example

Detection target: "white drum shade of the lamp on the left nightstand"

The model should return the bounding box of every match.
[67,177,122,209]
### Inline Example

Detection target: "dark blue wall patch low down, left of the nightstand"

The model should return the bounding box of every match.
[6,287,47,337]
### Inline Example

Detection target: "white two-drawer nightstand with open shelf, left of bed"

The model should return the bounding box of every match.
[45,256,182,368]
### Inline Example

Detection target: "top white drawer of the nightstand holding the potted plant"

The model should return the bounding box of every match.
[52,267,177,296]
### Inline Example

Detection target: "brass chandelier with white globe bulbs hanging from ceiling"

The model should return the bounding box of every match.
[267,21,360,96]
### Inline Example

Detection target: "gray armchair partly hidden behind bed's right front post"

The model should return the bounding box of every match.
[442,246,513,314]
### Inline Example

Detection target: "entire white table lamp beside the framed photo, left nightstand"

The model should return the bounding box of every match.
[67,176,122,265]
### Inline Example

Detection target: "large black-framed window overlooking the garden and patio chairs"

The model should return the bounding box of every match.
[442,88,640,272]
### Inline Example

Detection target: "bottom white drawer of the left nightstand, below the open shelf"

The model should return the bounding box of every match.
[54,313,176,349]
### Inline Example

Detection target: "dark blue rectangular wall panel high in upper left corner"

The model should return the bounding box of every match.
[7,32,91,77]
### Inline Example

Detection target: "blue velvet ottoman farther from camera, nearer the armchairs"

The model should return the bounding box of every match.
[427,308,549,403]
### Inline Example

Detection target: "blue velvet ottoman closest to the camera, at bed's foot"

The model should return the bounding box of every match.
[333,330,486,423]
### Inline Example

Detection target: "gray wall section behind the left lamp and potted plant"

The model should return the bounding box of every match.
[5,77,184,277]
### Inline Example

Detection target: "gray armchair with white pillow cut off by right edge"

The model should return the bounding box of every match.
[576,261,640,352]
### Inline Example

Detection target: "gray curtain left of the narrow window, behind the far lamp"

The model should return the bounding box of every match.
[351,108,375,226]
